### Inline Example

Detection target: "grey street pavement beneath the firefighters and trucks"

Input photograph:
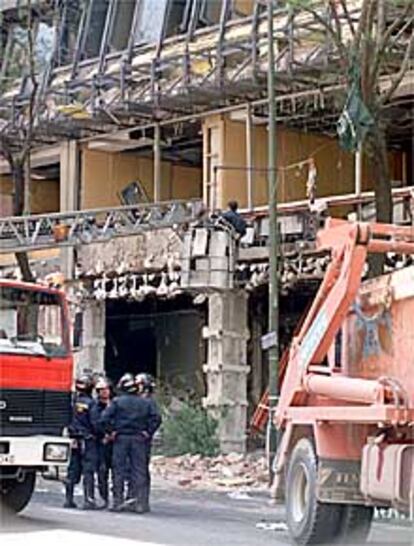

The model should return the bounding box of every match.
[0,481,414,546]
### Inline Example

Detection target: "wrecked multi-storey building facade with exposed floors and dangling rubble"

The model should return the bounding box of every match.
[0,0,413,451]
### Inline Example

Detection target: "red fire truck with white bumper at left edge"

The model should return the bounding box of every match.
[0,280,73,512]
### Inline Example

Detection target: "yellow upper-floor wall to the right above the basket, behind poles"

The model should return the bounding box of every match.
[207,116,402,208]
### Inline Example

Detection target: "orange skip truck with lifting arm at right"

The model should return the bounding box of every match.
[253,219,414,546]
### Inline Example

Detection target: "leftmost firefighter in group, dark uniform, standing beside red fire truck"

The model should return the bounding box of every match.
[64,374,97,510]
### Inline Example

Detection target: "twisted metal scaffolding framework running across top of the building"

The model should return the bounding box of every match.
[0,0,412,149]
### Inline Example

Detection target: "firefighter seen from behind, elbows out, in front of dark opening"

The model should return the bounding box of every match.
[101,374,161,514]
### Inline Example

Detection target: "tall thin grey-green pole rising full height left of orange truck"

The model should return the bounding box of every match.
[267,0,279,475]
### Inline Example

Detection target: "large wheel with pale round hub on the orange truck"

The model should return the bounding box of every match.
[286,438,342,546]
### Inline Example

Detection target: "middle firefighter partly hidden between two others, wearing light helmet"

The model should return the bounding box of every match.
[95,377,113,507]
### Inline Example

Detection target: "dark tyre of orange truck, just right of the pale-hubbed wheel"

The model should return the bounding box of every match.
[337,504,374,545]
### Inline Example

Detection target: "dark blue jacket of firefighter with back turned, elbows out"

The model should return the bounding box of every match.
[100,393,161,437]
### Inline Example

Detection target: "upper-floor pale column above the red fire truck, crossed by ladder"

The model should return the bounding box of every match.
[60,140,79,279]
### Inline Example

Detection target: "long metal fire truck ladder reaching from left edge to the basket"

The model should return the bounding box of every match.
[0,199,203,254]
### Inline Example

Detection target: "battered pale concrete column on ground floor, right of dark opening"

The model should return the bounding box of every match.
[203,291,249,453]
